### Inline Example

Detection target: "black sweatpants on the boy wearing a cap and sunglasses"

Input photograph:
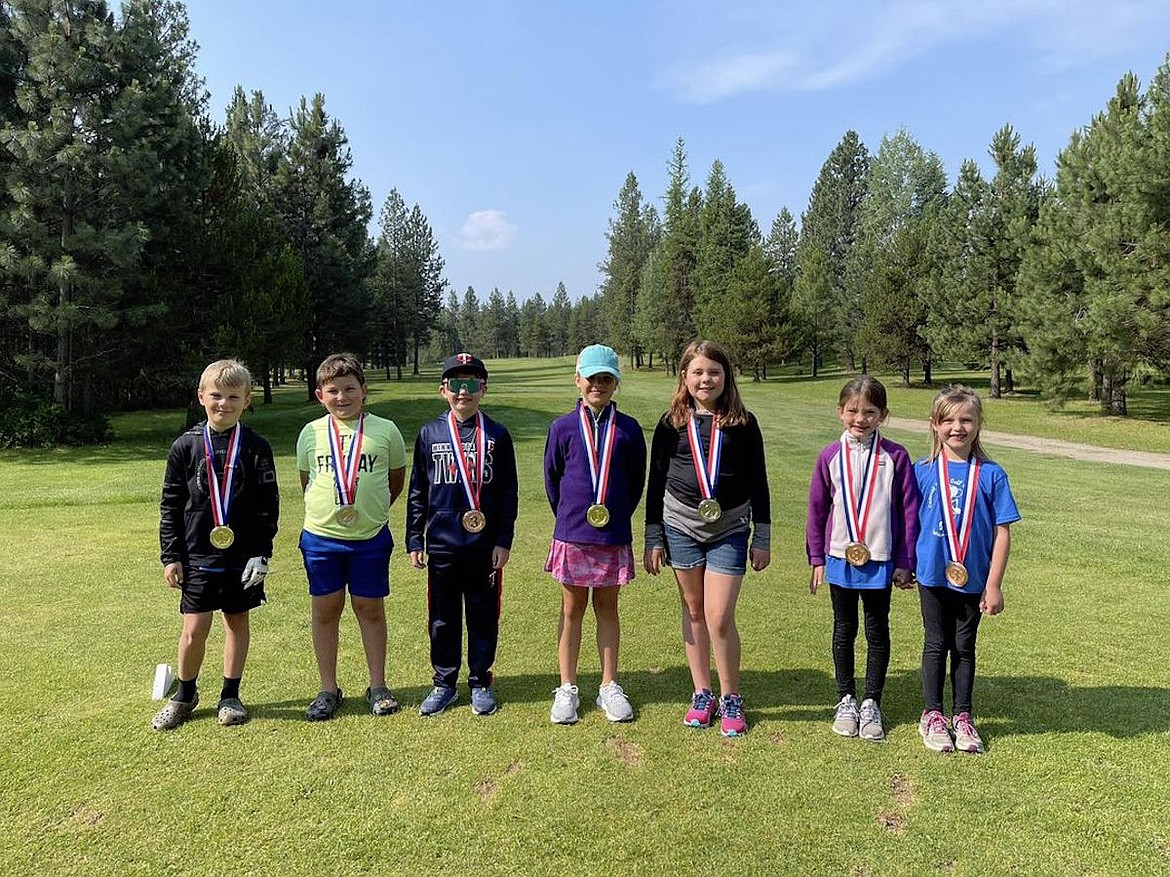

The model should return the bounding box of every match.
[427,554,503,689]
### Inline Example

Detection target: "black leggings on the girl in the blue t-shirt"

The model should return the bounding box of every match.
[918,585,980,716]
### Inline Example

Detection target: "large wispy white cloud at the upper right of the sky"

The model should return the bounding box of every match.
[663,0,1170,104]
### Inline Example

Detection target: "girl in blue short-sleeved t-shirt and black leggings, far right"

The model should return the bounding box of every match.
[914,385,1020,752]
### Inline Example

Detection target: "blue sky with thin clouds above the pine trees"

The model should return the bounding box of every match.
[187,0,1170,301]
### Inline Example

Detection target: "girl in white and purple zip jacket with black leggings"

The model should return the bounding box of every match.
[805,375,918,743]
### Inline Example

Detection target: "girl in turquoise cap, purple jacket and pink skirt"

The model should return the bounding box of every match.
[544,344,646,725]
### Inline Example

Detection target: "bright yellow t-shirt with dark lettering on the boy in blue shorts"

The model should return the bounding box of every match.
[296,412,406,540]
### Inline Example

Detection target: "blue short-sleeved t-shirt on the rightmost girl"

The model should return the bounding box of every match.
[914,460,1020,594]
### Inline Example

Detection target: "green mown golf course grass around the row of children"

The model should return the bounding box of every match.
[0,359,1170,877]
